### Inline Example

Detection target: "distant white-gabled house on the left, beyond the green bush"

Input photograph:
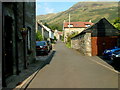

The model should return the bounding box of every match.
[36,22,54,40]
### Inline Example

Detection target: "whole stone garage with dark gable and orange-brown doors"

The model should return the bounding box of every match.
[71,18,120,56]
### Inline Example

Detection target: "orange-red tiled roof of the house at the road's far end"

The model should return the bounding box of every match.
[64,22,93,28]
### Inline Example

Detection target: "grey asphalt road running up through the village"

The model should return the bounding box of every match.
[28,41,118,88]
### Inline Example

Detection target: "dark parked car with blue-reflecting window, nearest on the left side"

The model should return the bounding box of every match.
[36,41,49,54]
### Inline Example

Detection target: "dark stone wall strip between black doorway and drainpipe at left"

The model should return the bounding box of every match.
[16,3,24,71]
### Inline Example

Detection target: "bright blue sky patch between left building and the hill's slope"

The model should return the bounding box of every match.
[36,2,76,15]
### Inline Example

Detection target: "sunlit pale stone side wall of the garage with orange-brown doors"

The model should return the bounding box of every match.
[71,33,92,56]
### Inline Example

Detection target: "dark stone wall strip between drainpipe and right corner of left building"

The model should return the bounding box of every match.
[25,2,36,63]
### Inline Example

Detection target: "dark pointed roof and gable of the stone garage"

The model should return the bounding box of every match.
[71,18,120,39]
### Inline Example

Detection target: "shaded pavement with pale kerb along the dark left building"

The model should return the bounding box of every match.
[3,50,54,89]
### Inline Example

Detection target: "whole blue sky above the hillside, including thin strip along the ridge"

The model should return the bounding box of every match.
[36,0,119,15]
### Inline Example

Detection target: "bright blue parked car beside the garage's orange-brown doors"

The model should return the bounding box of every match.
[103,47,120,59]
